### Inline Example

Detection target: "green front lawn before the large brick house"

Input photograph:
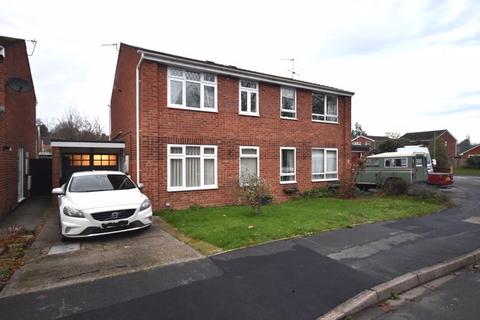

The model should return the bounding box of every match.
[156,197,445,250]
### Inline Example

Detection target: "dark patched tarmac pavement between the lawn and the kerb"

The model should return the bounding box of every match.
[0,178,480,319]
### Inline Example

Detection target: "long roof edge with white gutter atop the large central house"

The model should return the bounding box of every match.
[121,43,355,96]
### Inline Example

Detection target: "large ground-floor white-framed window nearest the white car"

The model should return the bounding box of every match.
[167,144,217,191]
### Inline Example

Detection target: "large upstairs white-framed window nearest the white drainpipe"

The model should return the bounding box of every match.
[167,67,217,112]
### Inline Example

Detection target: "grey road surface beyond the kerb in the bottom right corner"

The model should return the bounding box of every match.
[352,265,480,320]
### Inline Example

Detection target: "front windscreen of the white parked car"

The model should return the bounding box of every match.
[69,174,135,192]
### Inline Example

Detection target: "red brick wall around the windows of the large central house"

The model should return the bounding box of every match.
[112,45,351,209]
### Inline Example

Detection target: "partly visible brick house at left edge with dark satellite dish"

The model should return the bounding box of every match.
[0,36,37,217]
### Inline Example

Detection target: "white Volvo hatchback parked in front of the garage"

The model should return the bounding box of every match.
[52,171,152,240]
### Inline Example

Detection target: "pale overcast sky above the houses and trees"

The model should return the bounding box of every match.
[0,0,480,142]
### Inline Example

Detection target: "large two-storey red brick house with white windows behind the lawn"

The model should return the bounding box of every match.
[111,44,353,209]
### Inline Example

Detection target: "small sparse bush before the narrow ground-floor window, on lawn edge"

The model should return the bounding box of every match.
[238,175,272,214]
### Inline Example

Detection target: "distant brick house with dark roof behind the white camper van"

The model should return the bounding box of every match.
[401,129,457,163]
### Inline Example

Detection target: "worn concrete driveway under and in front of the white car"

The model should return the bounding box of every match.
[0,207,203,297]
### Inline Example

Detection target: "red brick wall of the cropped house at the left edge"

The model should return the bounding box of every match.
[0,41,37,217]
